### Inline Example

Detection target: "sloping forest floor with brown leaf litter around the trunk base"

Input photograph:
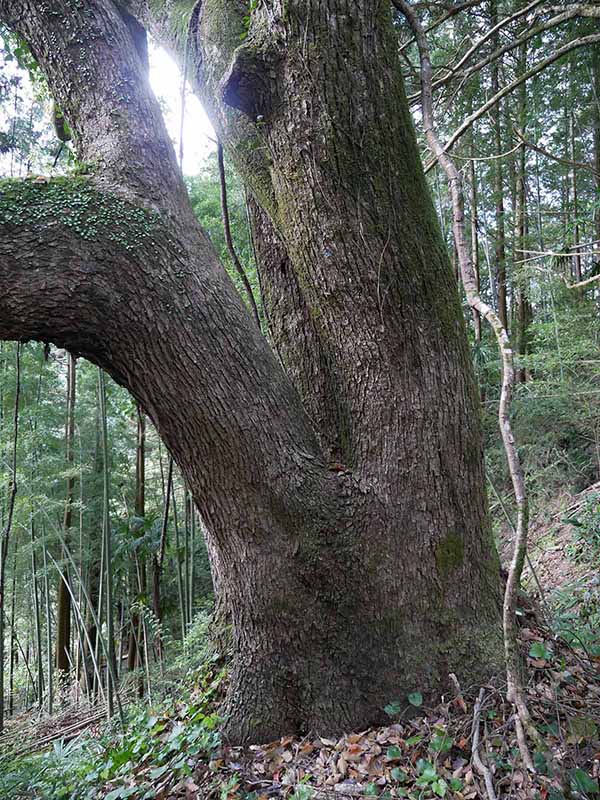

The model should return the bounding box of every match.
[1,486,600,800]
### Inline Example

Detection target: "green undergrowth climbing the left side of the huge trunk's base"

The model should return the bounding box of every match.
[0,614,227,800]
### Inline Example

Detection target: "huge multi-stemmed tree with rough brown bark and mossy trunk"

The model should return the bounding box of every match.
[0,0,502,740]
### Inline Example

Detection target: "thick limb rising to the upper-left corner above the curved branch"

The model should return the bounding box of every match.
[0,0,186,216]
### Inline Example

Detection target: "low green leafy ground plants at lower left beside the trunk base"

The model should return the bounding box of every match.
[0,668,224,800]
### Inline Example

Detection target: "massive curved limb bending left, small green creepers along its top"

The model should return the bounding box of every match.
[0,179,321,517]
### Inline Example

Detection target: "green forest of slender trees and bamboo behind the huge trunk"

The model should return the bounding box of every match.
[0,0,600,800]
